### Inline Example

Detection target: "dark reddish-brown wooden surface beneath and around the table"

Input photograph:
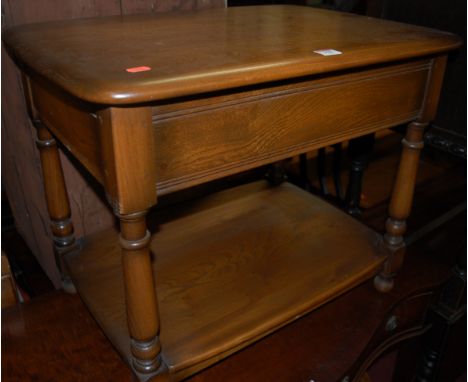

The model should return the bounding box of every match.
[2,130,466,382]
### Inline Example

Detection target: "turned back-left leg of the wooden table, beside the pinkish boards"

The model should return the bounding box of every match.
[34,120,76,293]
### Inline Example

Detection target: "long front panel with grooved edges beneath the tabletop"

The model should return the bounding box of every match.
[153,61,430,194]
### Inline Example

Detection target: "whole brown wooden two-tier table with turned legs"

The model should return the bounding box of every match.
[4,6,460,380]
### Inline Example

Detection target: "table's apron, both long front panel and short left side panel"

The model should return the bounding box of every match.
[30,59,433,195]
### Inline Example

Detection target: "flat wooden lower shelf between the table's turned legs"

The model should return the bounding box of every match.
[66,182,386,379]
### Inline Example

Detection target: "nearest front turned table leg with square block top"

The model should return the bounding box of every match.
[98,107,167,380]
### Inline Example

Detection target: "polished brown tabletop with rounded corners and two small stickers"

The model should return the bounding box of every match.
[3,5,460,104]
